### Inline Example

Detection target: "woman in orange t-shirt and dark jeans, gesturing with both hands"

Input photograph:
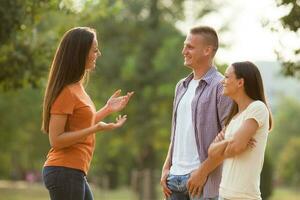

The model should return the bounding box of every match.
[42,27,133,200]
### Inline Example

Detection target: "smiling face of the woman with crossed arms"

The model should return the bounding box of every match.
[222,65,244,97]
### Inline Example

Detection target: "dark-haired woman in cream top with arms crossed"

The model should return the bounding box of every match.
[208,62,272,200]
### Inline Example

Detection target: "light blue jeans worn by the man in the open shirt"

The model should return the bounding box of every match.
[167,174,218,200]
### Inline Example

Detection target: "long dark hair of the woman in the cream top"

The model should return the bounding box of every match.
[225,61,273,130]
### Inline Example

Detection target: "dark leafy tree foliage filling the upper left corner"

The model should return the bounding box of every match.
[0,0,58,90]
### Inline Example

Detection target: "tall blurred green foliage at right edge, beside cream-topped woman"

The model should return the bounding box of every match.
[268,98,300,186]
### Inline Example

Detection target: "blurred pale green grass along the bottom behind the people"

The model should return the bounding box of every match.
[0,181,300,200]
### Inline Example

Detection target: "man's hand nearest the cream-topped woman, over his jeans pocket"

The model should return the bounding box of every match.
[187,169,207,197]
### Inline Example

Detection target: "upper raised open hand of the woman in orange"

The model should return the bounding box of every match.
[106,90,134,112]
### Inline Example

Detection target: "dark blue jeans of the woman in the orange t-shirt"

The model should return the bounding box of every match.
[43,166,93,200]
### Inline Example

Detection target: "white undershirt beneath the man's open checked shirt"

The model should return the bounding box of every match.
[170,79,200,175]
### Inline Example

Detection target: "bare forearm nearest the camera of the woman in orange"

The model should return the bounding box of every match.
[49,124,98,149]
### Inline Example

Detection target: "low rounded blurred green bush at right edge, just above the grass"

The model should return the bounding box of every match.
[278,136,300,187]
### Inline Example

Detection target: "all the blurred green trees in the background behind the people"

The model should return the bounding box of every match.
[0,0,300,200]
